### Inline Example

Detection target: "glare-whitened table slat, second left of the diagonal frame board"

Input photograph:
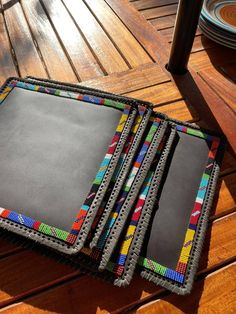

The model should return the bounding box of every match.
[64,0,129,74]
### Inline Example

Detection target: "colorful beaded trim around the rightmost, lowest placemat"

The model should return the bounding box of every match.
[138,125,220,283]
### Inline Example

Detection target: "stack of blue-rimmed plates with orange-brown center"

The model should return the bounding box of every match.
[199,0,236,49]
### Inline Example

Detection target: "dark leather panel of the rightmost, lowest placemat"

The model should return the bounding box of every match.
[142,132,209,269]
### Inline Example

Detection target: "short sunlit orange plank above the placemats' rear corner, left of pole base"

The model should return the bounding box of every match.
[125,82,182,105]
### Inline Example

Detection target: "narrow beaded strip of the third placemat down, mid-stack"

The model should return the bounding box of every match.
[91,118,161,260]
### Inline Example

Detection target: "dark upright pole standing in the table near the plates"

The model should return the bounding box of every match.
[167,0,203,74]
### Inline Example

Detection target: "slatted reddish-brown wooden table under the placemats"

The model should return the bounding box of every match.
[0,0,236,314]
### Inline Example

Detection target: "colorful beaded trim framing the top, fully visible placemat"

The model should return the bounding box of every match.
[0,80,132,244]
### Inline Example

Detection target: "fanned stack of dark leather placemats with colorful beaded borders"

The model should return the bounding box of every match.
[0,77,223,294]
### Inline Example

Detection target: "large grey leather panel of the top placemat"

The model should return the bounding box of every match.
[0,88,122,231]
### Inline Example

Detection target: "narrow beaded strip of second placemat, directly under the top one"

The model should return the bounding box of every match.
[88,106,146,242]
